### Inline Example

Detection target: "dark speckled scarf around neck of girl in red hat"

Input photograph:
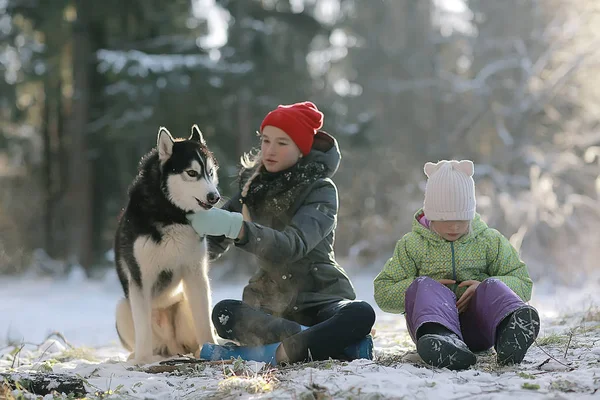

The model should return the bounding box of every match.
[240,162,328,217]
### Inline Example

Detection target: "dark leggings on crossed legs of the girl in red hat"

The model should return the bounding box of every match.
[212,300,375,362]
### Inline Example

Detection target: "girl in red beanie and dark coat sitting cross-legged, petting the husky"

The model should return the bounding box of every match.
[188,101,375,365]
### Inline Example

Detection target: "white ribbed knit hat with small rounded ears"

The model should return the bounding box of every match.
[423,160,476,221]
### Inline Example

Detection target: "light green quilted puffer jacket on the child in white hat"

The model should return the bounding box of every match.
[373,210,533,313]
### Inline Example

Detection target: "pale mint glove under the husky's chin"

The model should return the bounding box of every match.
[186,207,244,239]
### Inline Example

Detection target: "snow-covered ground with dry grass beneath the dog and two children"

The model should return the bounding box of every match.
[0,272,600,399]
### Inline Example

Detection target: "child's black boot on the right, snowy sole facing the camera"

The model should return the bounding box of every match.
[494,305,540,365]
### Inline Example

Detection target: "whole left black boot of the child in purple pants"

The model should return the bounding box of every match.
[417,323,477,370]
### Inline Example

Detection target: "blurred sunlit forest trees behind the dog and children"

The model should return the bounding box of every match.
[0,0,600,282]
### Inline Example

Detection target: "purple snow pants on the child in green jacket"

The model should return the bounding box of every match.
[405,276,525,351]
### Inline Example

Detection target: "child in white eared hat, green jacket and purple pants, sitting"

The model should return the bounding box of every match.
[374,160,539,369]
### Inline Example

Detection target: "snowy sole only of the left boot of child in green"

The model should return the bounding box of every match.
[417,335,477,370]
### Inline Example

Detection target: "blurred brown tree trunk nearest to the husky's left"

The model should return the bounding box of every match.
[66,0,94,269]
